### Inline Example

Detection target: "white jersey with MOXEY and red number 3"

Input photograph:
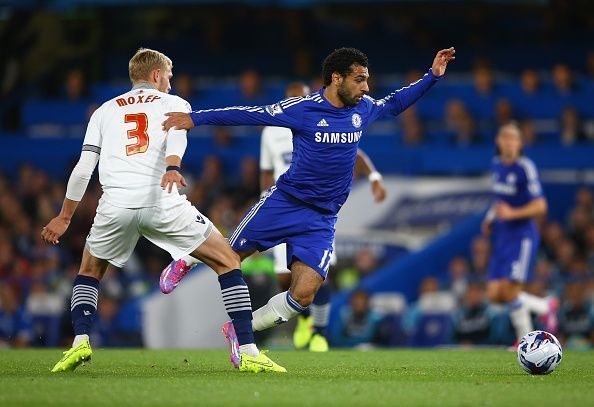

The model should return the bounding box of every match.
[83,85,191,208]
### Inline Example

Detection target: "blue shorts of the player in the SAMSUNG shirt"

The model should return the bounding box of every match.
[229,186,338,279]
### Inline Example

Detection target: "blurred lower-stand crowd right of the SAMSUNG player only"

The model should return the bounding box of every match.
[332,187,594,350]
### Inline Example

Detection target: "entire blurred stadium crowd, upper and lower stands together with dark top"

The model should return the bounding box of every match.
[0,0,594,347]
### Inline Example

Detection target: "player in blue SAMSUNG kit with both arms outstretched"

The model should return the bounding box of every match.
[163,47,455,367]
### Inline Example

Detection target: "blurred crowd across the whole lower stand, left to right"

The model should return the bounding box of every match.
[0,157,594,348]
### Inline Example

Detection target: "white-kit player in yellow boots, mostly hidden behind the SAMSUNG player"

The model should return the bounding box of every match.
[260,82,386,352]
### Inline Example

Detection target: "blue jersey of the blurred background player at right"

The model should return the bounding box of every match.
[493,157,543,233]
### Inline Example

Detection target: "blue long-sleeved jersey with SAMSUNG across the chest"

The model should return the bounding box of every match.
[191,70,438,213]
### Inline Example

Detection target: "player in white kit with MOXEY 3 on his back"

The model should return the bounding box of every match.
[41,48,286,372]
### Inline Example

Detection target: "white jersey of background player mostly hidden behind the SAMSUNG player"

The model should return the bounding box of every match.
[260,126,293,180]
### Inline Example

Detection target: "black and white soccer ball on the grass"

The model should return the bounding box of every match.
[518,331,563,374]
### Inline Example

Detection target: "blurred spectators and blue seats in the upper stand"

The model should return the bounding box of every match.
[6,62,594,147]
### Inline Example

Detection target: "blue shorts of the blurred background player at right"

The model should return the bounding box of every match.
[489,232,539,283]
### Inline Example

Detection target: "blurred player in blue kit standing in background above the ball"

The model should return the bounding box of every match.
[482,123,558,346]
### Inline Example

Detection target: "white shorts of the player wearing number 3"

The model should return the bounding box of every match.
[87,195,213,267]
